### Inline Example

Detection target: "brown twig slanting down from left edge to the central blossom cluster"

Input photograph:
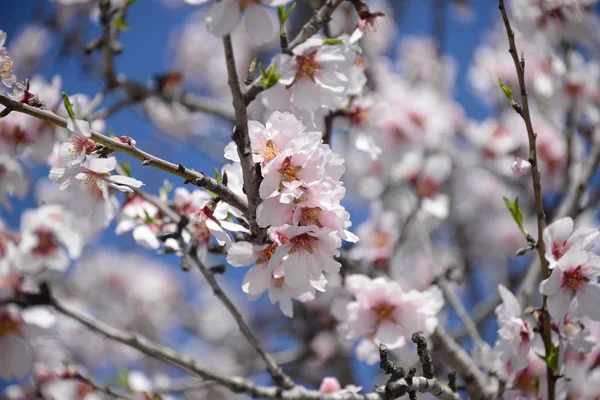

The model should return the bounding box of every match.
[0,95,248,213]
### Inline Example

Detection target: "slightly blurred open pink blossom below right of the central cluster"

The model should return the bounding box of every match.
[339,275,444,364]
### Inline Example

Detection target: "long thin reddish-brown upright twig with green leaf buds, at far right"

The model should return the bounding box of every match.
[498,0,556,400]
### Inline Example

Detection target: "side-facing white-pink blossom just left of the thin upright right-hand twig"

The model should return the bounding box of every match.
[496,285,534,371]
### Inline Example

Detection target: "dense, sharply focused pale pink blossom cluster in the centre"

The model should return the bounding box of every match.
[225,112,358,317]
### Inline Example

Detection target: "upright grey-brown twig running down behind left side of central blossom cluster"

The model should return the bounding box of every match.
[223,35,267,243]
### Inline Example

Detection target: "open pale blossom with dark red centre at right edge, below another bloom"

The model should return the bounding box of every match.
[540,246,600,325]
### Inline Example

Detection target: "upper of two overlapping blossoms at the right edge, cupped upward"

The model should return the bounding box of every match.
[543,217,600,268]
